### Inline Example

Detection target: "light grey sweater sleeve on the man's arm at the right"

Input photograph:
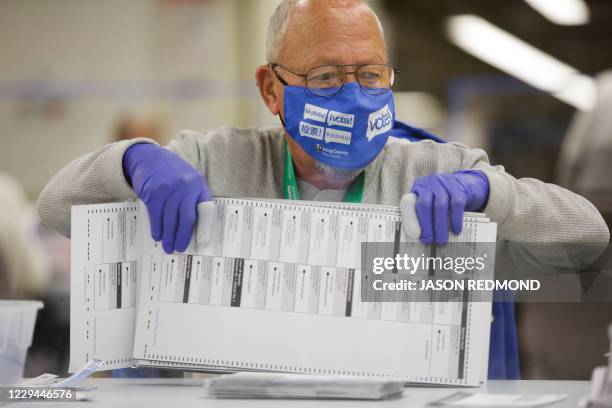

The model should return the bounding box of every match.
[463,149,610,244]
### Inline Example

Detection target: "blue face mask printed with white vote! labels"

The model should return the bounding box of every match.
[284,82,395,170]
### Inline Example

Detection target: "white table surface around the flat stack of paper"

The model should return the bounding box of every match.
[10,378,589,408]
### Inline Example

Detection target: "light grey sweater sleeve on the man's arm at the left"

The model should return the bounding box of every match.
[37,139,154,237]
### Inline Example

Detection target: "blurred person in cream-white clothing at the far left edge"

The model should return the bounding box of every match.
[0,172,49,299]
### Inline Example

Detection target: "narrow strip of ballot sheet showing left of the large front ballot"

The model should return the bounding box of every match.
[69,202,146,372]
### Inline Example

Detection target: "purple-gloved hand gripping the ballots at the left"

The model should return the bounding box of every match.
[123,143,212,254]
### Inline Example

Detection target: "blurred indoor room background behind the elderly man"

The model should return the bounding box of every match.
[0,0,612,379]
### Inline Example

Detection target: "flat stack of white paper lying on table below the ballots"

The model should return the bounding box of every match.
[206,373,404,400]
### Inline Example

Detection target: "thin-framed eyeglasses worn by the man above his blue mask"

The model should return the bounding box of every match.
[270,63,399,96]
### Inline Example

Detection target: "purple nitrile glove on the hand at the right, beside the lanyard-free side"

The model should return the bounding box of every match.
[411,170,489,244]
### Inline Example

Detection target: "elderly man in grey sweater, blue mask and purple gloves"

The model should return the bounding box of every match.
[39,0,609,378]
